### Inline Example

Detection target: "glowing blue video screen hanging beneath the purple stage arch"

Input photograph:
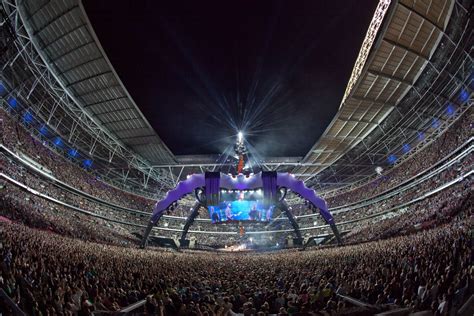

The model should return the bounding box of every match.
[208,190,274,224]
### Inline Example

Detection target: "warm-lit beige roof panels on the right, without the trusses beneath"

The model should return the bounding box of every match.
[296,0,454,179]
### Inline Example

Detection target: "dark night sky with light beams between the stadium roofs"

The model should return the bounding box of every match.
[84,0,377,157]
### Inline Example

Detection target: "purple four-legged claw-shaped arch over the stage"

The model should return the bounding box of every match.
[141,171,341,248]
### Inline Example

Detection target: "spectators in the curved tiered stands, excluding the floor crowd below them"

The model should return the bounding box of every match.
[0,130,473,247]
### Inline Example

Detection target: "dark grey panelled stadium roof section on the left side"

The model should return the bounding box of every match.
[16,0,174,163]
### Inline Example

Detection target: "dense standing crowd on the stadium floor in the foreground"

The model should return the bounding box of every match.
[0,220,474,315]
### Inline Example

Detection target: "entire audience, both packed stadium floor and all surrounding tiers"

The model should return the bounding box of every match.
[0,90,474,316]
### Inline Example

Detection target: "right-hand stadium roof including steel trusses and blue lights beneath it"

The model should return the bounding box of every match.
[294,0,474,194]
